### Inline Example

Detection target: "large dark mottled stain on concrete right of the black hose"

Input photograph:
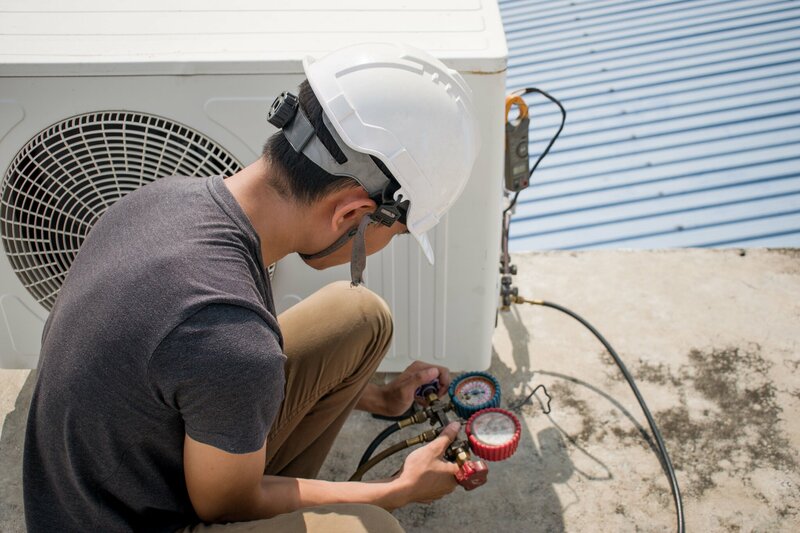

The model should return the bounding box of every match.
[613,346,797,497]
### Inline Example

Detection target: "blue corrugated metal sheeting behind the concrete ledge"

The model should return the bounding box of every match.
[500,0,800,251]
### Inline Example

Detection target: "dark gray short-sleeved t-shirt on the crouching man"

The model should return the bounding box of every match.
[23,177,285,532]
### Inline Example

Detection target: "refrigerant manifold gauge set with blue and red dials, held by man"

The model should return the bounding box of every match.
[350,372,522,490]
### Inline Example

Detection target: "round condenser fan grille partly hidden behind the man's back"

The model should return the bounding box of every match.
[0,111,241,309]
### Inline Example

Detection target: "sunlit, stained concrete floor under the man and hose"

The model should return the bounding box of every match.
[0,250,800,532]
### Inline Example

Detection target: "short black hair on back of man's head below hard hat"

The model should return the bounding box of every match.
[262,80,358,204]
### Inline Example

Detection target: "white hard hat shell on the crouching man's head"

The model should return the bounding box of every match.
[303,43,480,264]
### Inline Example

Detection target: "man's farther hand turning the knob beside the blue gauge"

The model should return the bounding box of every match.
[356,361,450,416]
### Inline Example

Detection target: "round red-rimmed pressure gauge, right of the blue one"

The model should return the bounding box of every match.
[465,407,522,461]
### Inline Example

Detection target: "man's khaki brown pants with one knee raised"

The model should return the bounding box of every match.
[185,282,403,533]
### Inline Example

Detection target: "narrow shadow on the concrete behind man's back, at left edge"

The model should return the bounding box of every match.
[0,370,36,533]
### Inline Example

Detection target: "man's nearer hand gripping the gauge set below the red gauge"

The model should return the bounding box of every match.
[394,422,460,503]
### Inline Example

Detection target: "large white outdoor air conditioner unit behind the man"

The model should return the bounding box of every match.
[0,0,507,371]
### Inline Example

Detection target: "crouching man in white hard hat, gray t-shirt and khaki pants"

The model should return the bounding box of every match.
[23,45,478,532]
